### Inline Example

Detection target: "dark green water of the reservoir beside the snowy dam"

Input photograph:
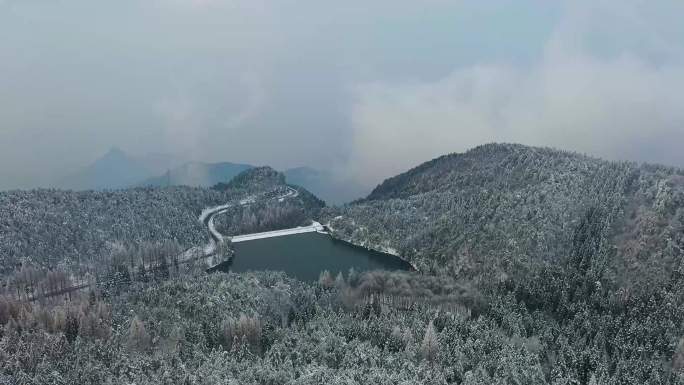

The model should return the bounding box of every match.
[211,233,412,281]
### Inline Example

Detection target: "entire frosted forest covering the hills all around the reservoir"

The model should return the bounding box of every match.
[0,145,684,385]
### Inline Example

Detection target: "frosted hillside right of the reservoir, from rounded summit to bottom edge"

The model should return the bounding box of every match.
[316,144,684,384]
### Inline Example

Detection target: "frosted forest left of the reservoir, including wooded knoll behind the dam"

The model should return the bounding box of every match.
[0,168,323,298]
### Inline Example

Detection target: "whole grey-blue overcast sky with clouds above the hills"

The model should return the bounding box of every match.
[0,0,684,188]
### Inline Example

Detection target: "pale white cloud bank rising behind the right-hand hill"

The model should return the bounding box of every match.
[349,1,684,183]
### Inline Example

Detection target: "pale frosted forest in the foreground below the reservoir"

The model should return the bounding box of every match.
[0,270,504,385]
